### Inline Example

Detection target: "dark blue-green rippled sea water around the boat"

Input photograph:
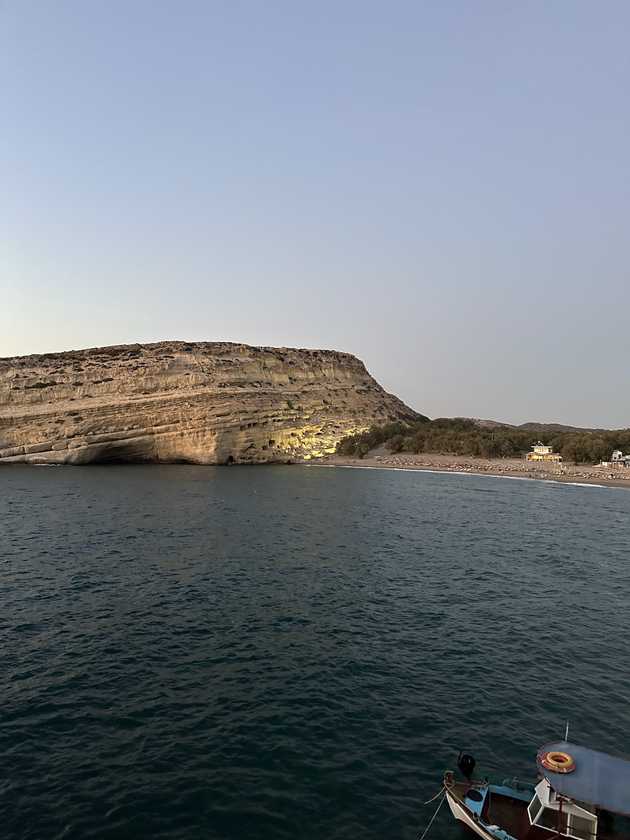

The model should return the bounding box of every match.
[0,466,630,840]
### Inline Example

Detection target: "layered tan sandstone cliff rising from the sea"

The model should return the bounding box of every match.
[0,342,417,464]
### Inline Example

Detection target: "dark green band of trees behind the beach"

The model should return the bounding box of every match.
[337,418,630,464]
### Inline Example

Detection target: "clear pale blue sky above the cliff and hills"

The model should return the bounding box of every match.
[0,0,630,426]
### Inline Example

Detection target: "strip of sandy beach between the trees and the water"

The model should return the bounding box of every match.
[310,456,630,489]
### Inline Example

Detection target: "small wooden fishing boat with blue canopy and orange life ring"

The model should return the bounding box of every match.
[444,740,630,840]
